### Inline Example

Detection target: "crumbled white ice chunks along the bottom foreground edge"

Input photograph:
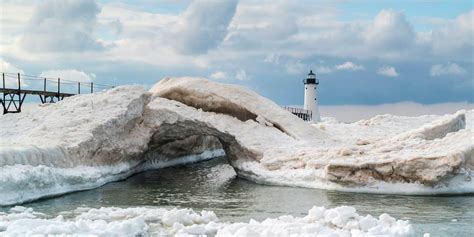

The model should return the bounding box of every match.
[0,206,414,237]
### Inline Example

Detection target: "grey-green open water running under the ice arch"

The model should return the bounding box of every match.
[4,158,474,236]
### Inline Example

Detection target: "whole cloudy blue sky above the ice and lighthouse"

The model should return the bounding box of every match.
[0,0,474,105]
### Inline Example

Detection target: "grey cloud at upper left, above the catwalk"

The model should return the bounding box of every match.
[20,0,104,53]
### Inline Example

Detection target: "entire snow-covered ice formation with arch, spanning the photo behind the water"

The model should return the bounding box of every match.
[0,77,474,205]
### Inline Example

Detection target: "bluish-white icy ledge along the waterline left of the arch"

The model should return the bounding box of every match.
[0,149,225,206]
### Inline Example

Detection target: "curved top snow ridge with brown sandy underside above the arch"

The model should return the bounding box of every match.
[150,77,324,139]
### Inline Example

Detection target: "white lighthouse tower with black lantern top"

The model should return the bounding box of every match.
[303,70,321,122]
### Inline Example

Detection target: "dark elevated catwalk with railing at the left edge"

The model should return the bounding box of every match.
[0,72,113,114]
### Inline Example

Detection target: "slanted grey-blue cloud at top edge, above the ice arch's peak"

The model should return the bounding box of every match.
[172,0,237,54]
